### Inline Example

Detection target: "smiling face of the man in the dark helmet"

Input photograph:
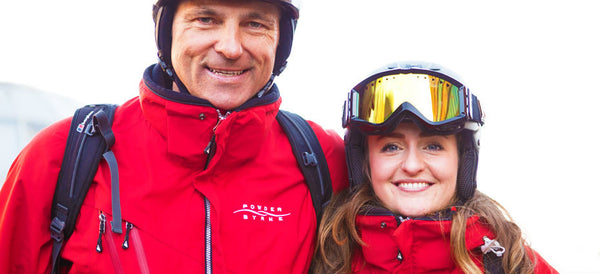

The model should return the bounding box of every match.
[171,0,280,110]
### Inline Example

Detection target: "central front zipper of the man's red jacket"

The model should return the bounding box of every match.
[204,109,231,274]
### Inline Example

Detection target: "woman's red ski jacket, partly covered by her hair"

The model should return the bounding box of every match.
[352,209,558,273]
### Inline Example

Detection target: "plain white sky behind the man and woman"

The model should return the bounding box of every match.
[0,0,600,273]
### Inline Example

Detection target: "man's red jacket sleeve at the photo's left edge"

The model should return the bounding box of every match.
[0,118,70,273]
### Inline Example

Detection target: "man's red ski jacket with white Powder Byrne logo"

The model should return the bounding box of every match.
[0,63,347,273]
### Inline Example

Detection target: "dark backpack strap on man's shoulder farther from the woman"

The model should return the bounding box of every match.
[50,105,118,273]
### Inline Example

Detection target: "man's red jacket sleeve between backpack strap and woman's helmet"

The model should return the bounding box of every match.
[308,121,348,193]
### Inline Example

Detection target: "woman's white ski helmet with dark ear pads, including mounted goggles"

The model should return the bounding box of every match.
[342,62,484,201]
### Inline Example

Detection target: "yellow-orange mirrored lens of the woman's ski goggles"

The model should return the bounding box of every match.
[358,74,464,124]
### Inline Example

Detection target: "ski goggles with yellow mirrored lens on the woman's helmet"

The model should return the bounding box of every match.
[343,68,483,134]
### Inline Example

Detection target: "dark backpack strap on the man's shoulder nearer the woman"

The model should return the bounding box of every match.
[276,110,332,225]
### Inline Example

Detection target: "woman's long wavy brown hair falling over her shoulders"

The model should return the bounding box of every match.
[311,183,535,273]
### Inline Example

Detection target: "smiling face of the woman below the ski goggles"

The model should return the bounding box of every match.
[367,122,458,217]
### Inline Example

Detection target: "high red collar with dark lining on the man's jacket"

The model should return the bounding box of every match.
[140,64,281,168]
